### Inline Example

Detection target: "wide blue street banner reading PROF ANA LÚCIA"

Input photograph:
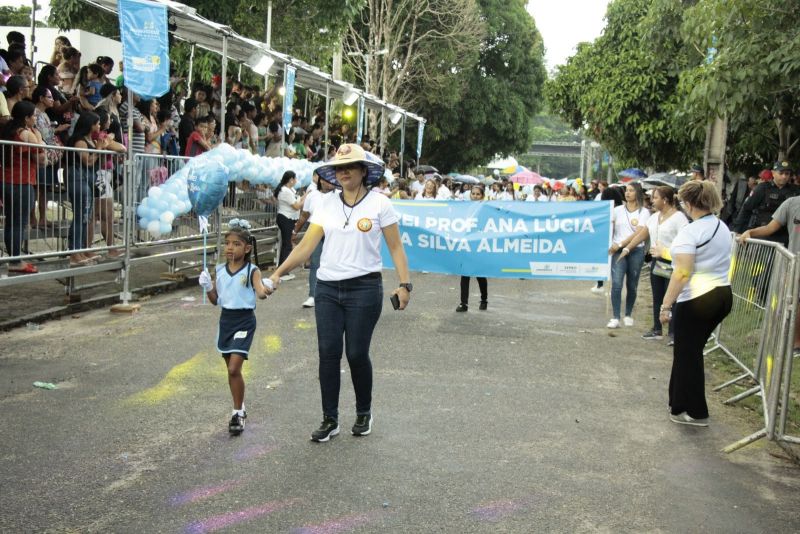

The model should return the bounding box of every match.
[382,200,613,280]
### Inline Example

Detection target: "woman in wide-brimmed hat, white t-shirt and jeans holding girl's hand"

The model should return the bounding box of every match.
[271,144,412,442]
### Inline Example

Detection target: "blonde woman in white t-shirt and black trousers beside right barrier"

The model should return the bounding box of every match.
[661,181,733,426]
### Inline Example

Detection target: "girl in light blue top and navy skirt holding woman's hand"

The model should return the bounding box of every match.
[198,219,270,435]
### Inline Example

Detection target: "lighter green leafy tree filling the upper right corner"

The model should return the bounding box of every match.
[681,0,800,166]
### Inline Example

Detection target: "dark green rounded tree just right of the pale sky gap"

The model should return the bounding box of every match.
[545,0,702,170]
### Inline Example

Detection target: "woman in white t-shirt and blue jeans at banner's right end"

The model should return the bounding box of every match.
[606,184,650,328]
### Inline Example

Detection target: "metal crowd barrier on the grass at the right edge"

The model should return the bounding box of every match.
[720,239,798,452]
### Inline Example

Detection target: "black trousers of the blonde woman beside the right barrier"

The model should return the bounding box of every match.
[669,286,733,419]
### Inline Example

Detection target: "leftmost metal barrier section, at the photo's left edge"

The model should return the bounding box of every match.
[0,141,125,293]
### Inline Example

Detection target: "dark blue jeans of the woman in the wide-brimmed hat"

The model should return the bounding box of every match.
[314,273,383,420]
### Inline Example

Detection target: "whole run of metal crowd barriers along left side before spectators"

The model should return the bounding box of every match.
[0,141,277,303]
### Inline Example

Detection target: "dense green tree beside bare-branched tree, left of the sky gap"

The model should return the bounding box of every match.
[422,0,546,171]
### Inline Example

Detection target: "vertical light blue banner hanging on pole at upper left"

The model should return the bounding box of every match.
[119,0,169,99]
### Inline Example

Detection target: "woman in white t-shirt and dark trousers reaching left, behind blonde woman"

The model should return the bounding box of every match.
[620,185,689,344]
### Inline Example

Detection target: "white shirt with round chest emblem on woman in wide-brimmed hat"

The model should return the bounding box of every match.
[310,191,399,282]
